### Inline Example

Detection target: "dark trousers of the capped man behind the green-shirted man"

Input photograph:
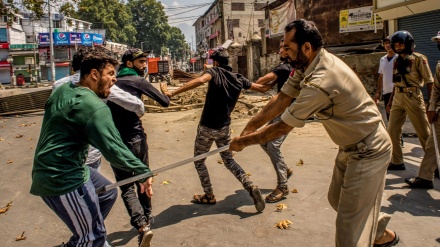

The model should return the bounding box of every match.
[112,135,151,229]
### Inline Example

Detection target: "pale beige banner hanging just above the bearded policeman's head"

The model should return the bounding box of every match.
[268,0,296,37]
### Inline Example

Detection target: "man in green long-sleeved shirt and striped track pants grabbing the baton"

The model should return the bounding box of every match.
[30,52,153,247]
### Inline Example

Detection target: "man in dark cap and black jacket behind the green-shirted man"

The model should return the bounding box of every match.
[107,48,170,247]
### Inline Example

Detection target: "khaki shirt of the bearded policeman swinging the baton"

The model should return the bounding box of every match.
[281,49,382,146]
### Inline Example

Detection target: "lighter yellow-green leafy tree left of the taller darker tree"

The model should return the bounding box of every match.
[77,0,136,44]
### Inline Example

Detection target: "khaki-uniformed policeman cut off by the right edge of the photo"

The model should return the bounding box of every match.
[405,32,440,189]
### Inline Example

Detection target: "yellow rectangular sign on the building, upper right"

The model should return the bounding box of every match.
[339,6,383,33]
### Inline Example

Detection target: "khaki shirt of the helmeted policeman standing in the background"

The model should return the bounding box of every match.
[393,52,434,88]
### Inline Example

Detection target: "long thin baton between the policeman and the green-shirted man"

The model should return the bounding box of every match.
[96,145,229,194]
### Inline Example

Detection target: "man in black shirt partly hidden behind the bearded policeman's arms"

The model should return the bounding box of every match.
[255,39,293,203]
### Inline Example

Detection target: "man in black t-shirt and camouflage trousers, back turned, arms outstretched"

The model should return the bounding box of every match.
[163,48,271,212]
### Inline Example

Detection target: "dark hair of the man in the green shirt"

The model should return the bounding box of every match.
[81,50,119,78]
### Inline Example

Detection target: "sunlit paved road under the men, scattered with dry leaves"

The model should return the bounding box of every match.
[0,109,440,247]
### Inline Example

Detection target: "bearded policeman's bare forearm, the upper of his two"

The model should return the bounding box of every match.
[241,92,293,136]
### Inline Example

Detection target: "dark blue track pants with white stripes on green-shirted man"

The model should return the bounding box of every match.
[42,169,118,247]
